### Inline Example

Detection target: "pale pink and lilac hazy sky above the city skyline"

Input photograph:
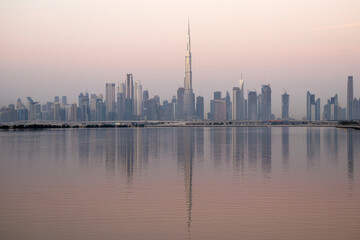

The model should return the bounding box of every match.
[0,0,360,118]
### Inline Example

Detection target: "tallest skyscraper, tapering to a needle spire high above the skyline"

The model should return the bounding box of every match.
[183,20,195,120]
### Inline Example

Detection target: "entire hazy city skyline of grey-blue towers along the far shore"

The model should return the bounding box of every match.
[0,21,360,122]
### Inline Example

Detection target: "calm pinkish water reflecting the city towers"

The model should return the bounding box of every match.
[0,127,360,240]
